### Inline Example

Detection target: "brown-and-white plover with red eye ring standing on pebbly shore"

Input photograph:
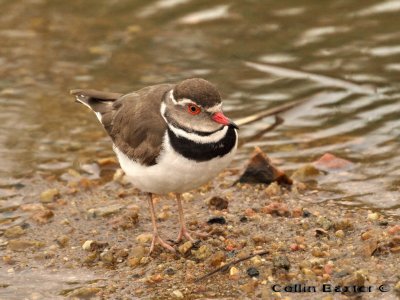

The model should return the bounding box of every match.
[70,78,238,254]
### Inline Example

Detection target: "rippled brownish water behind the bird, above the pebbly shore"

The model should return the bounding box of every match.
[0,0,400,215]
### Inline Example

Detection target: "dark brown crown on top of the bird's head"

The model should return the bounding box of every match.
[174,78,221,108]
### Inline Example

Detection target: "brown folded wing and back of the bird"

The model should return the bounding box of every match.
[73,84,174,166]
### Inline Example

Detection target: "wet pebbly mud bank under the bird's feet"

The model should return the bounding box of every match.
[0,161,400,299]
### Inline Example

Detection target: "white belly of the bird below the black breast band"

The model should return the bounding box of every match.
[114,135,237,194]
